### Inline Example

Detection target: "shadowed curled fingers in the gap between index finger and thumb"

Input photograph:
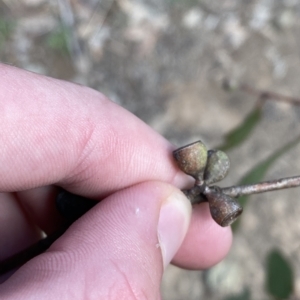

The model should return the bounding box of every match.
[0,186,63,268]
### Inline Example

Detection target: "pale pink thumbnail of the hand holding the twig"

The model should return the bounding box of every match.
[157,191,192,268]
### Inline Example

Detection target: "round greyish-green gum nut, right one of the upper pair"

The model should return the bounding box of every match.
[204,150,230,185]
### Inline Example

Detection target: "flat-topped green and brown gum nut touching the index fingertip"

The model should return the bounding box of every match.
[173,141,207,180]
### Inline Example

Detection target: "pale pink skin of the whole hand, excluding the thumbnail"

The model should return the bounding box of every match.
[0,65,232,299]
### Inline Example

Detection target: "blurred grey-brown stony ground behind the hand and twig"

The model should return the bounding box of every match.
[0,0,300,300]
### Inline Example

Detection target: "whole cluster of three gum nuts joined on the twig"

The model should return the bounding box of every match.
[173,141,243,227]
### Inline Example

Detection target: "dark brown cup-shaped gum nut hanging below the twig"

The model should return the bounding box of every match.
[205,188,243,227]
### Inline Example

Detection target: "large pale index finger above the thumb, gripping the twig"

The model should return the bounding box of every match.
[0,65,189,198]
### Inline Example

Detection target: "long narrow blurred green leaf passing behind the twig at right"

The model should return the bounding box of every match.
[232,137,300,230]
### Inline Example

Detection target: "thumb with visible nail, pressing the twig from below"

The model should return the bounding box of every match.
[0,182,191,299]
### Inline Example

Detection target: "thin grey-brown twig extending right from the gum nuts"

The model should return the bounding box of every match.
[221,176,300,198]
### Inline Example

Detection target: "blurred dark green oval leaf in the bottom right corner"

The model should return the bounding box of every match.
[266,249,294,299]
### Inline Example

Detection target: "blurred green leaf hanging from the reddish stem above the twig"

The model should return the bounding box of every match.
[218,107,261,151]
